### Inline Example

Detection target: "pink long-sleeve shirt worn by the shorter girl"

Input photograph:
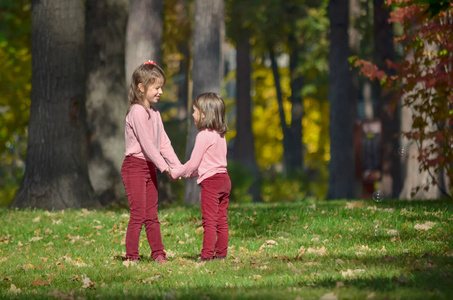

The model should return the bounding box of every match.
[171,129,227,184]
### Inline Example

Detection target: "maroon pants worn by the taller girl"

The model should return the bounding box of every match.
[121,156,165,260]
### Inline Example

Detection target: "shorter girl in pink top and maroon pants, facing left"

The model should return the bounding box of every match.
[170,93,231,261]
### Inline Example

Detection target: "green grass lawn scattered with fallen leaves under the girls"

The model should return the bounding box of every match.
[0,200,453,299]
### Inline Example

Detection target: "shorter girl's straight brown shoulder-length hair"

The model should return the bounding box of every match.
[193,92,228,134]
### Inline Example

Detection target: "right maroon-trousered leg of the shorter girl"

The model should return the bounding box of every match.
[215,173,231,257]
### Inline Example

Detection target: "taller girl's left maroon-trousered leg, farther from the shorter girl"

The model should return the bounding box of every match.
[121,157,149,260]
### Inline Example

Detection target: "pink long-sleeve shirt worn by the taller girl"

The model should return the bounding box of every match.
[124,104,181,172]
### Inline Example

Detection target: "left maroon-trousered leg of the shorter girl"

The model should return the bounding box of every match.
[201,177,219,259]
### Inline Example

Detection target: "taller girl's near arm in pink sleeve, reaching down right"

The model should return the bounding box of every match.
[129,109,168,172]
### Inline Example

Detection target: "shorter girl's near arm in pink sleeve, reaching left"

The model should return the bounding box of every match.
[171,131,211,179]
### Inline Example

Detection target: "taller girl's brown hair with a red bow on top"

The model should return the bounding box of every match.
[126,63,167,115]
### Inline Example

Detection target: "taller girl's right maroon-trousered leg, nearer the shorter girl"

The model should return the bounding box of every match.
[145,162,165,259]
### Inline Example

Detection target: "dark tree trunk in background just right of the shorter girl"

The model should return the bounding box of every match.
[233,34,261,202]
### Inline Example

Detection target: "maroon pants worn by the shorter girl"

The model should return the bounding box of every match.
[200,173,231,259]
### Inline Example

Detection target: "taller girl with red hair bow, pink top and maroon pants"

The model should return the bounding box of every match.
[121,61,181,263]
